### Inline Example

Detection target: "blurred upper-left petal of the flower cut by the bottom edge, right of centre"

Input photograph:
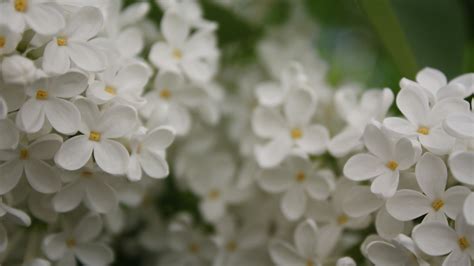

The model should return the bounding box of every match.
[269,240,306,266]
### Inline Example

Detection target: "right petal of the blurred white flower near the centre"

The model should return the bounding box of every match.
[296,125,329,155]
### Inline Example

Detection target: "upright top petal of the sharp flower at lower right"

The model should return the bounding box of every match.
[415,153,448,199]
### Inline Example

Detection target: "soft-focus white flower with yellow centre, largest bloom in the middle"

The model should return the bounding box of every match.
[252,90,329,168]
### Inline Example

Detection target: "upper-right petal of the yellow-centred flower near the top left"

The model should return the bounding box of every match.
[65,6,104,41]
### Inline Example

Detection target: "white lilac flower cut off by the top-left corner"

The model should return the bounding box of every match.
[0,0,65,35]
